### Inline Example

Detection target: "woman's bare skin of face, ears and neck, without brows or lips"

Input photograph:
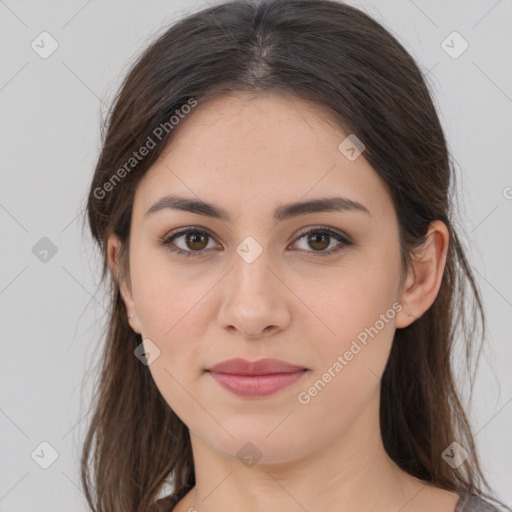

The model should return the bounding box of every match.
[108,94,458,512]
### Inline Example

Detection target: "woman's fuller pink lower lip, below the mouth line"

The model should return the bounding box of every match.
[208,370,306,397]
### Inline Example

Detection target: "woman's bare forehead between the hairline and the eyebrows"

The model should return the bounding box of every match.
[134,94,392,224]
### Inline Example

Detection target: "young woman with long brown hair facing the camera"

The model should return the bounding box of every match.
[82,0,510,512]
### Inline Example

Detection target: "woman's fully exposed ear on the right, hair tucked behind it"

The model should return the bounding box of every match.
[395,220,450,329]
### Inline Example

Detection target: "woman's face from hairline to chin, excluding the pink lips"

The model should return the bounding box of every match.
[110,95,414,463]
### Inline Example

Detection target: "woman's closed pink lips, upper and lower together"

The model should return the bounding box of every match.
[206,358,308,397]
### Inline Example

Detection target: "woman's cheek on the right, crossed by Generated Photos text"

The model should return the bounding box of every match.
[305,252,401,402]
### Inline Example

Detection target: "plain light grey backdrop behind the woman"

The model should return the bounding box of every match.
[0,0,512,512]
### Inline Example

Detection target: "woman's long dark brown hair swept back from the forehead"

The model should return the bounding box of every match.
[81,0,508,512]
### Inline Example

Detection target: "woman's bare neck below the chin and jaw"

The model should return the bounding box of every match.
[183,389,425,512]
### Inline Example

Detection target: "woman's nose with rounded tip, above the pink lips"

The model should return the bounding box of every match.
[218,251,291,339]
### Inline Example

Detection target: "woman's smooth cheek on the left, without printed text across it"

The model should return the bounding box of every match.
[132,262,214,428]
